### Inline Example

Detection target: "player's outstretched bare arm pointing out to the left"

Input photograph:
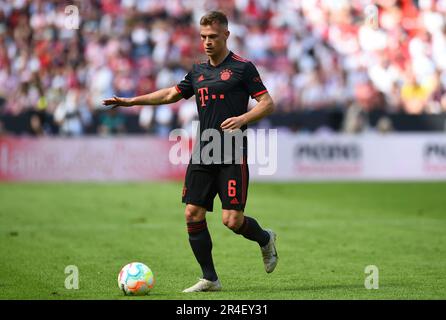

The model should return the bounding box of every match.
[102,86,183,107]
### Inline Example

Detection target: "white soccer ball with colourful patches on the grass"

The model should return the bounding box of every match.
[118,262,155,296]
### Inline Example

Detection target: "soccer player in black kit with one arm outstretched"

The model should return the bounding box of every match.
[103,11,278,292]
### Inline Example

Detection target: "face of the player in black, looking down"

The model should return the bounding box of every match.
[200,23,229,57]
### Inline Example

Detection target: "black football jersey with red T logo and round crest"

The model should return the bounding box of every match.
[176,51,267,163]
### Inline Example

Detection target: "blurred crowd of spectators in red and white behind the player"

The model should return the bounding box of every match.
[0,0,446,136]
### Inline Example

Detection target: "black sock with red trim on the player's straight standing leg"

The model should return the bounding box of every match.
[187,219,218,281]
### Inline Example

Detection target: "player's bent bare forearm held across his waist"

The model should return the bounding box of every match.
[221,92,275,130]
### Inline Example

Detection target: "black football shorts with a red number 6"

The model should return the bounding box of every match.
[183,161,249,211]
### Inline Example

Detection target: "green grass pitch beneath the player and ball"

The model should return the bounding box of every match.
[0,182,446,300]
